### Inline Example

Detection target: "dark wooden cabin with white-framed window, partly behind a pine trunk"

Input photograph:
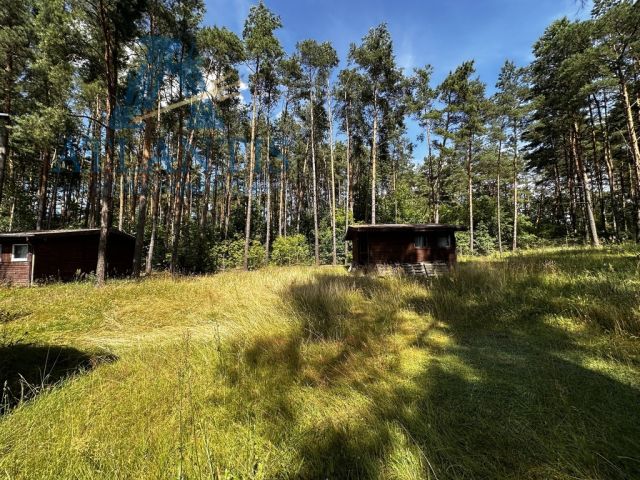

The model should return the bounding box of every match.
[0,228,135,285]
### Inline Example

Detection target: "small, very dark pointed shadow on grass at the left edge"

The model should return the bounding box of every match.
[0,343,117,415]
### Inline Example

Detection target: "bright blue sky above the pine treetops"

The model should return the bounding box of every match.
[204,0,590,160]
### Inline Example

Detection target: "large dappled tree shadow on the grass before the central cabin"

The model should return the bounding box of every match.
[216,256,640,479]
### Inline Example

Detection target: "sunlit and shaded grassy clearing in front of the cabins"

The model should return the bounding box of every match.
[0,248,640,480]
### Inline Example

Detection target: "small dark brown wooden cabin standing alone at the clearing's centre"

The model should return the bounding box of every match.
[346,223,464,276]
